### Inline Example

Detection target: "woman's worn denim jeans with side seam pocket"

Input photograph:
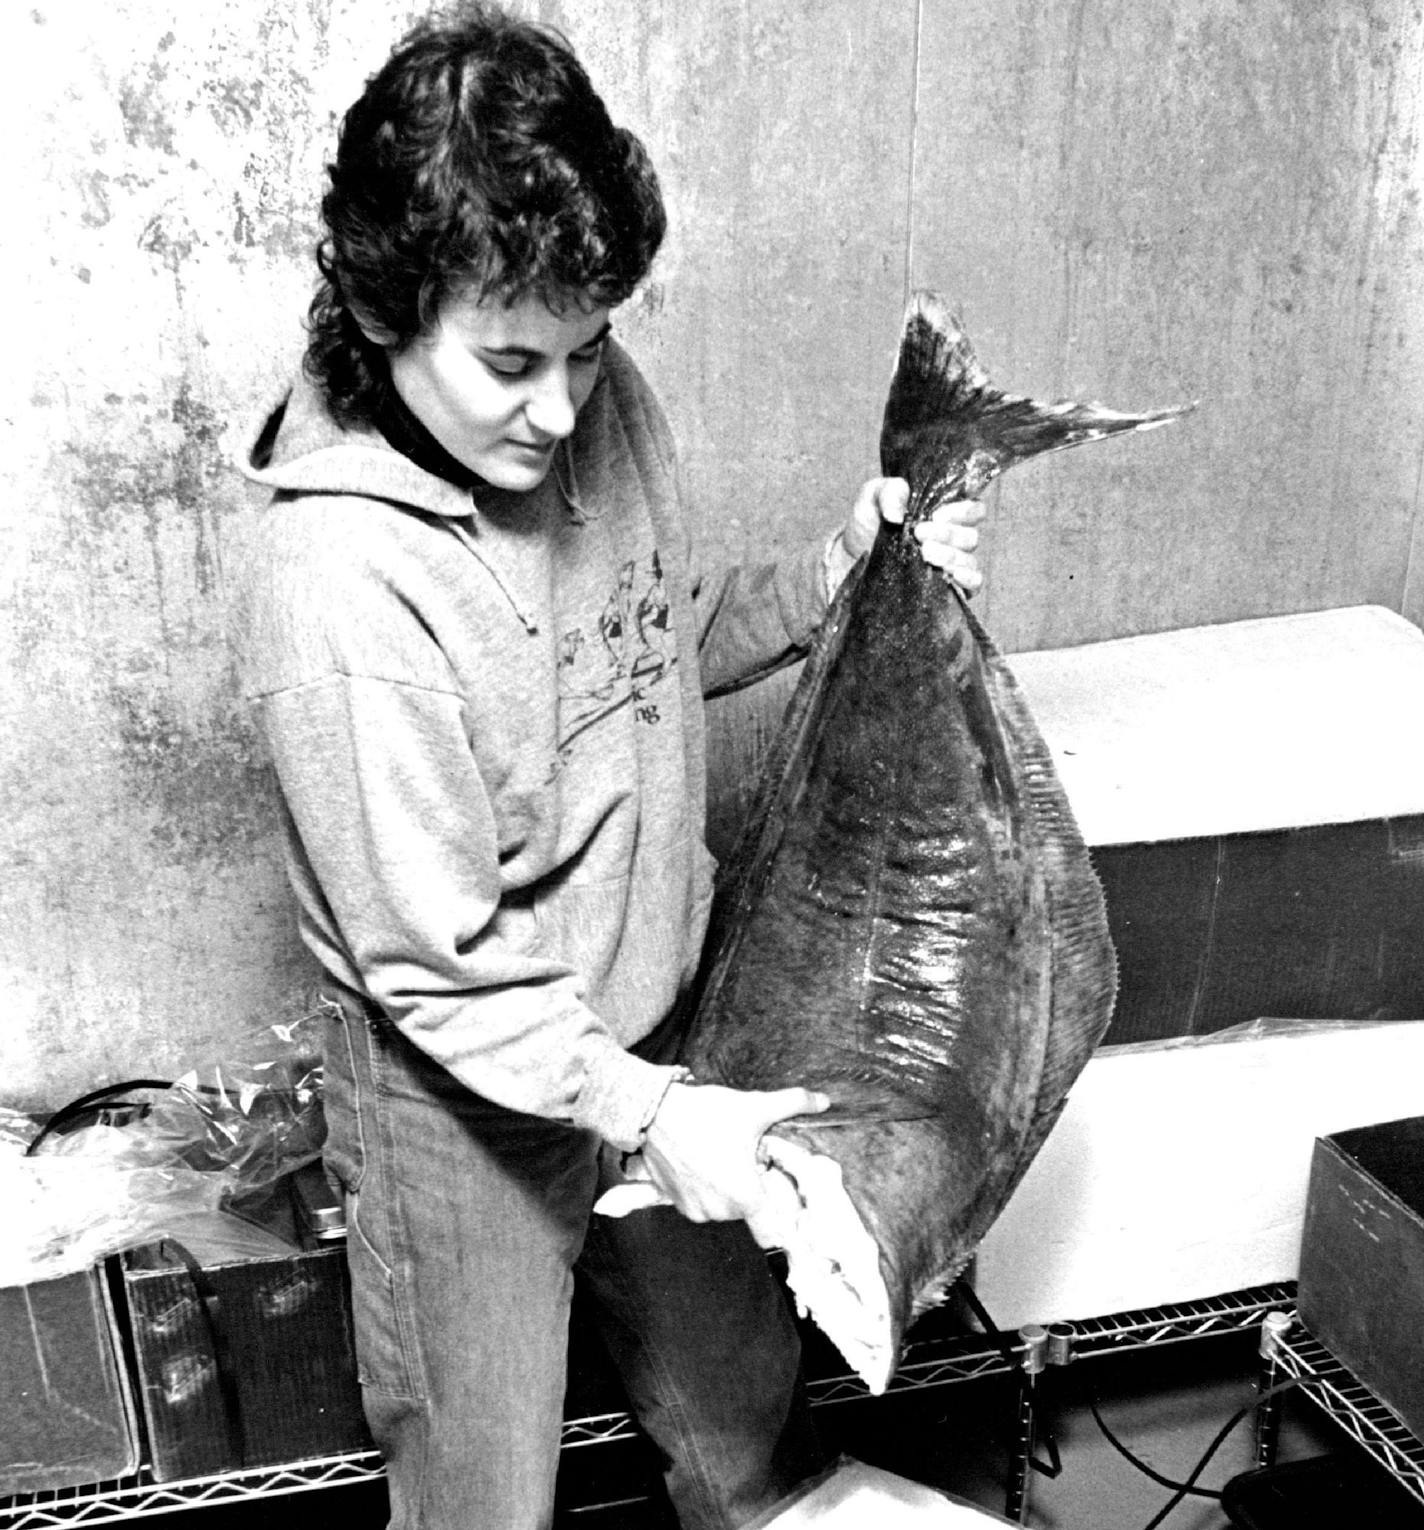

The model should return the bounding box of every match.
[326,991,826,1530]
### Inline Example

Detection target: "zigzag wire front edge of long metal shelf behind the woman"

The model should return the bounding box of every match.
[0,1284,1296,1530]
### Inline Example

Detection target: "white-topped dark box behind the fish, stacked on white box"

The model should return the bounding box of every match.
[1009,606,1424,1043]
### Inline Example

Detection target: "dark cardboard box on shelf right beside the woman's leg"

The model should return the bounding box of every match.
[124,1244,372,1483]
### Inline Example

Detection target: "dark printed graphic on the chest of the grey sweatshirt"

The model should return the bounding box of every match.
[558,552,678,765]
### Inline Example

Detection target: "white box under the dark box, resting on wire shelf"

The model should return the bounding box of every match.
[974,1015,1424,1330]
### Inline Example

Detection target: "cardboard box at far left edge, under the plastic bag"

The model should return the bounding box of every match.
[0,1270,139,1498]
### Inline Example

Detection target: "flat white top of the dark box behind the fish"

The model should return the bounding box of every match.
[1008,606,1424,846]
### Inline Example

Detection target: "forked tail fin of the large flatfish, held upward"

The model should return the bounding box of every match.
[879,291,1195,522]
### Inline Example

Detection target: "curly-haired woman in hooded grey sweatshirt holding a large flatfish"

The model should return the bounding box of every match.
[243,5,980,1530]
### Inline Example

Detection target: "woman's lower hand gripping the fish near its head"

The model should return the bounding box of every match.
[639,1083,831,1222]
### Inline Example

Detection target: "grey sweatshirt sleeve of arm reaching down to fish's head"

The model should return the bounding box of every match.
[258,673,678,1149]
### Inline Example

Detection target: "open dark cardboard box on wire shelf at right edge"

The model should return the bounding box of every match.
[1299,1115,1424,1437]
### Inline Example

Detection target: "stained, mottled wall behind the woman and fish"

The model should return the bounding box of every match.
[0,0,1424,1106]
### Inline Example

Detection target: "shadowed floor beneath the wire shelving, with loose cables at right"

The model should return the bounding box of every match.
[147,1333,1424,1530]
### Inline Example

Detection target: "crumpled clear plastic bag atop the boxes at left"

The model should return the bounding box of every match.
[0,1014,326,1285]
